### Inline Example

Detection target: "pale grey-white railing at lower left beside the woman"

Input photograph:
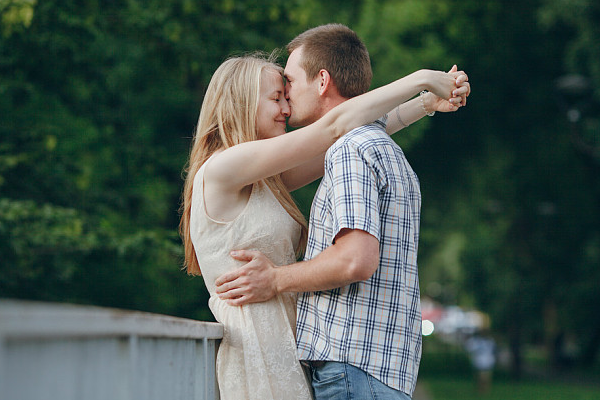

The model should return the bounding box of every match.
[0,300,223,400]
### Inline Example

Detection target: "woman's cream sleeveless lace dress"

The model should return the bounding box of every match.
[190,163,311,400]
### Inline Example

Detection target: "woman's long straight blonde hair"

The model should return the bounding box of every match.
[179,54,307,275]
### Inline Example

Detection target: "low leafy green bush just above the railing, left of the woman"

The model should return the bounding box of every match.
[0,199,209,319]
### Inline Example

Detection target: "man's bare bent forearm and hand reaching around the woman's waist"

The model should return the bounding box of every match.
[216,229,379,306]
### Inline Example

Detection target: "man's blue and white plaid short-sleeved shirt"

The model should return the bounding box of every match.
[297,119,421,396]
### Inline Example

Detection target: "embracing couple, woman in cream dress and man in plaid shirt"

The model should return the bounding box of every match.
[180,24,470,400]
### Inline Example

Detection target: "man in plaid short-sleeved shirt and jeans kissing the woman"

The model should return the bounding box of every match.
[216,24,470,399]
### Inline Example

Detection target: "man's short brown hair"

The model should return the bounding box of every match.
[287,24,373,98]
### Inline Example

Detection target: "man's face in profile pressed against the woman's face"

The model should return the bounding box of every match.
[283,46,321,127]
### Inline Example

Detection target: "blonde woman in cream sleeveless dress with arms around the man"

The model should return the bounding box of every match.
[180,56,459,400]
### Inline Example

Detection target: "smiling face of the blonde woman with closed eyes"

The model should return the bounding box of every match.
[256,68,290,139]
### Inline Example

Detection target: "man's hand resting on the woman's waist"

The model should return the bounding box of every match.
[215,250,277,306]
